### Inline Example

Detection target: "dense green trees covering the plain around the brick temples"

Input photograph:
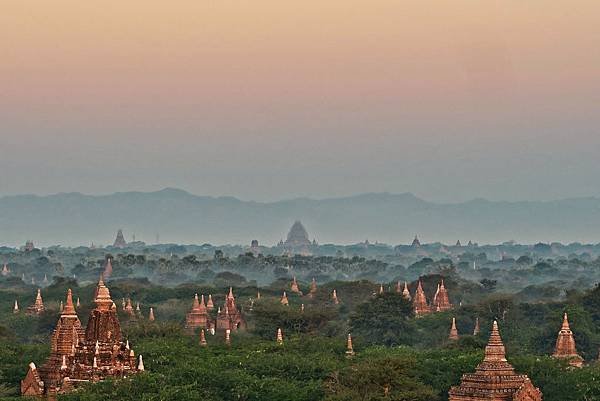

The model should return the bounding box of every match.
[0,247,600,401]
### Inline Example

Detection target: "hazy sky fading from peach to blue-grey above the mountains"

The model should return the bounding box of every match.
[0,0,600,202]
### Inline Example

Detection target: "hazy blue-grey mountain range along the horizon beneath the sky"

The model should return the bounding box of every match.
[0,189,600,246]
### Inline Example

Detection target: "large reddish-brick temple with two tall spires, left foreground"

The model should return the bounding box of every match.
[21,278,144,396]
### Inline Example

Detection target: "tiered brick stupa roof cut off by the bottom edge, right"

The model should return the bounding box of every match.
[448,321,542,401]
